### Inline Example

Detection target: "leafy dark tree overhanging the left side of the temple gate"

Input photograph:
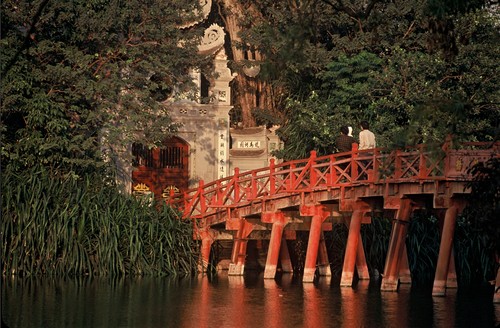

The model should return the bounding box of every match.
[0,0,207,176]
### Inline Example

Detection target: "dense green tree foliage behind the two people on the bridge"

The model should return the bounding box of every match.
[235,0,500,159]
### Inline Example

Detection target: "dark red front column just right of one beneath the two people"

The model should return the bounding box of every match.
[380,198,412,291]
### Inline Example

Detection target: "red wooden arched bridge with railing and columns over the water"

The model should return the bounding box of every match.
[169,142,500,295]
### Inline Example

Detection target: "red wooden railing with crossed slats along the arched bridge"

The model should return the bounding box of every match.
[169,143,499,218]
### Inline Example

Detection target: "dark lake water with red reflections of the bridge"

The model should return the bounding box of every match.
[2,272,500,328]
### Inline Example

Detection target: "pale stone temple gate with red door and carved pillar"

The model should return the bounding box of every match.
[120,1,281,199]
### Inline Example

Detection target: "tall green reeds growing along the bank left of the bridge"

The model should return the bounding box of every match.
[1,167,198,276]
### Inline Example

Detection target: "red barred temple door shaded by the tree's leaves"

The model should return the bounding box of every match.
[132,137,189,199]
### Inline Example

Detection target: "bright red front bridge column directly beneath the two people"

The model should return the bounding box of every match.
[340,209,365,287]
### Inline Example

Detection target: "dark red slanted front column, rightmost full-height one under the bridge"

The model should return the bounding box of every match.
[432,203,458,296]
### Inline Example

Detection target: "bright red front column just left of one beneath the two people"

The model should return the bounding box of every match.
[300,205,328,282]
